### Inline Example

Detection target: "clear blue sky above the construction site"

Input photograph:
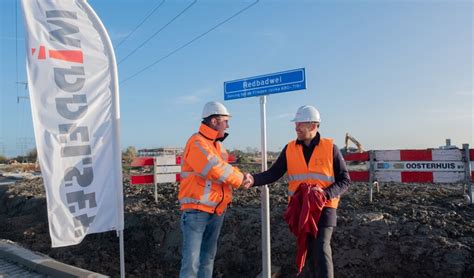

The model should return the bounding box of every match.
[0,0,474,157]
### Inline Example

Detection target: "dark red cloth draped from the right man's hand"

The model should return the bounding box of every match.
[284,183,326,273]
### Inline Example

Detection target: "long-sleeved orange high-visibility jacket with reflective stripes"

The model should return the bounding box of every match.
[178,124,244,215]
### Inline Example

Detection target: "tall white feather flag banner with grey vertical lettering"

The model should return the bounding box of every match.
[22,0,123,247]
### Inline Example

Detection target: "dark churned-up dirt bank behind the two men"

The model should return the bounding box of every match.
[0,173,474,277]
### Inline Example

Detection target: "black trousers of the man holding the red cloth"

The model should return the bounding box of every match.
[298,227,334,278]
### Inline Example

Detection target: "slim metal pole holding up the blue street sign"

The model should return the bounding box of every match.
[260,96,272,278]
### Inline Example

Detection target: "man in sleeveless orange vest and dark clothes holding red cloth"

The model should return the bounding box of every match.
[244,105,350,277]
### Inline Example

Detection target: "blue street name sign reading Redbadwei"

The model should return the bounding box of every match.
[224,68,306,100]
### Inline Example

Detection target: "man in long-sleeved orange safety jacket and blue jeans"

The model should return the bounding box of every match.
[178,101,248,278]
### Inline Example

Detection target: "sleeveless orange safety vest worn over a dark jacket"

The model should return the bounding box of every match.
[286,138,339,208]
